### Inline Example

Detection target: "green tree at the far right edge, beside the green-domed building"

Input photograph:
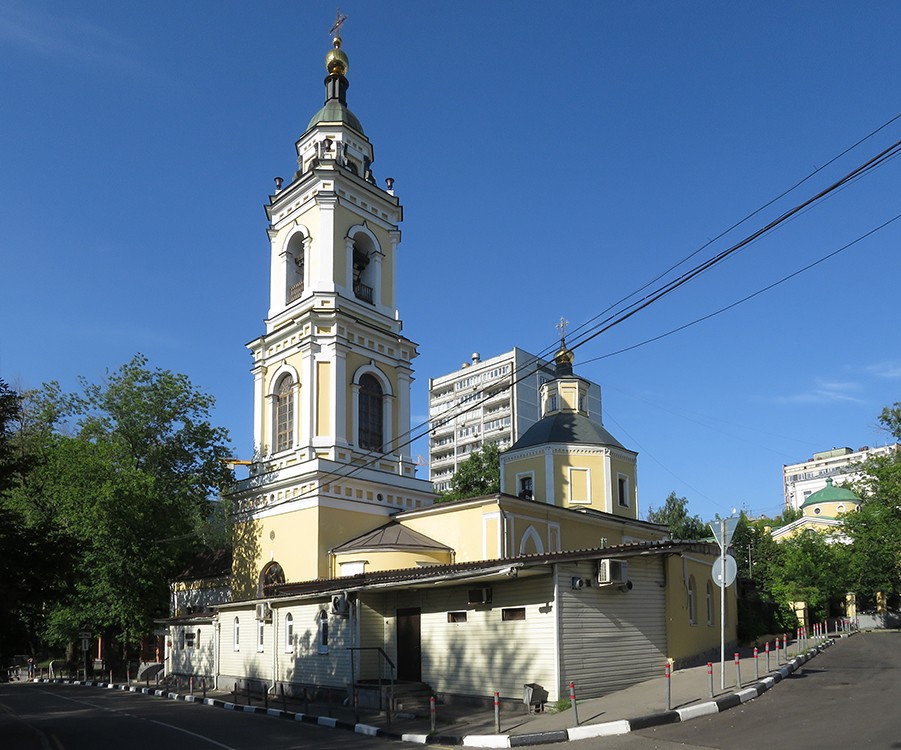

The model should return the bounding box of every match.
[842,403,901,607]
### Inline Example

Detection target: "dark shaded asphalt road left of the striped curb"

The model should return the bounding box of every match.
[0,683,422,750]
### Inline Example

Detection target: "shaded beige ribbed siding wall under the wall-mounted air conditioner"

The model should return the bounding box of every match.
[559,557,666,698]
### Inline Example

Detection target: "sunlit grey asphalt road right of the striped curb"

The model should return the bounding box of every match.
[564,631,901,750]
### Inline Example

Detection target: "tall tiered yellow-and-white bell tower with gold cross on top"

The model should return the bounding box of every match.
[234,25,434,595]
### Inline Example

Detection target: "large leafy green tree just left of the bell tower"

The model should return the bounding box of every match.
[5,355,231,646]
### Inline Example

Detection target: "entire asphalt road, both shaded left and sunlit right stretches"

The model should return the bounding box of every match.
[0,632,901,750]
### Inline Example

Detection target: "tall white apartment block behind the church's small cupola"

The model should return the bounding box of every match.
[429,347,601,492]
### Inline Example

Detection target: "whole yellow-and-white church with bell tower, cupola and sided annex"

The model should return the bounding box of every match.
[165,26,736,706]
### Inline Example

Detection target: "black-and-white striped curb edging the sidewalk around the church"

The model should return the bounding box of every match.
[32,640,833,748]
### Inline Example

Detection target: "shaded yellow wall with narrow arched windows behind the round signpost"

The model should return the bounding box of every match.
[665,553,737,666]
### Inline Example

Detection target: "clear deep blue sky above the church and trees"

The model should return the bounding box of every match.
[0,0,901,518]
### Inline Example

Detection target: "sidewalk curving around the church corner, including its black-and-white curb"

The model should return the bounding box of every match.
[35,635,839,748]
